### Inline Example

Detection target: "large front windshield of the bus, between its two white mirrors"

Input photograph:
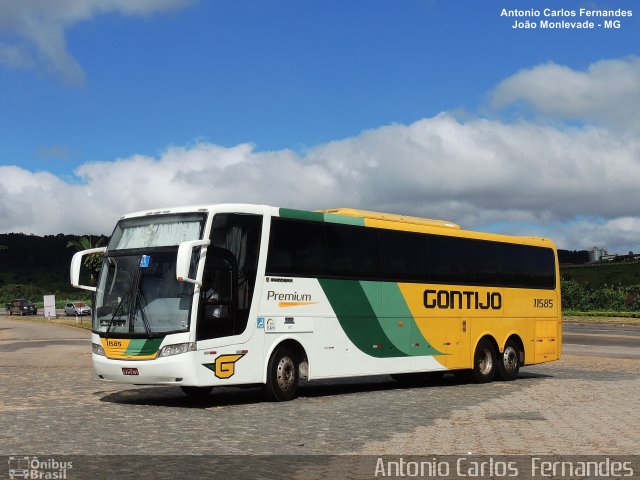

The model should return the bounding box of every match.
[93,214,205,337]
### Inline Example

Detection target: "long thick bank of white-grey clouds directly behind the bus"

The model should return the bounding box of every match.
[0,114,640,250]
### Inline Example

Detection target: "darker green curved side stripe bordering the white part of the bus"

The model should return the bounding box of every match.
[319,279,407,358]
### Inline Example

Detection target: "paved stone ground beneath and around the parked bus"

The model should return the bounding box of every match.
[0,316,640,464]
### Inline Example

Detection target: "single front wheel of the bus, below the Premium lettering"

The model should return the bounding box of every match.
[264,347,300,402]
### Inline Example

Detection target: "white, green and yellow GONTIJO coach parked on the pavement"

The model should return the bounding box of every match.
[71,204,561,400]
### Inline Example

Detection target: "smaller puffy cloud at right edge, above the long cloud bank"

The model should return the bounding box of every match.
[491,56,640,131]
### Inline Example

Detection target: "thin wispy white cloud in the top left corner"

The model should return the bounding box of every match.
[0,0,190,84]
